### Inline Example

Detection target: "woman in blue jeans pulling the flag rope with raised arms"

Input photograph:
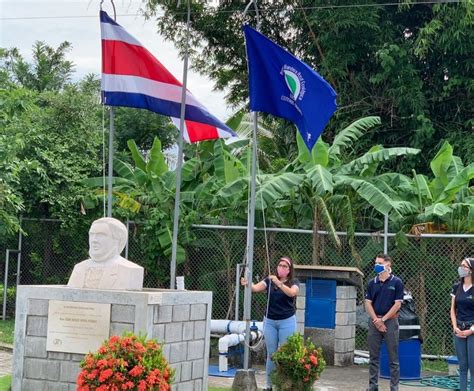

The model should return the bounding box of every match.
[240,257,299,390]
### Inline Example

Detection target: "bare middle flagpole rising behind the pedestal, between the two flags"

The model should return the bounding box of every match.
[170,0,191,289]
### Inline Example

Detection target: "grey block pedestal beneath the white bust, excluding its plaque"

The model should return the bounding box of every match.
[12,286,212,391]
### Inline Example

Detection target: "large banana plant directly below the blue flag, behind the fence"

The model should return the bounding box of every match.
[291,117,419,263]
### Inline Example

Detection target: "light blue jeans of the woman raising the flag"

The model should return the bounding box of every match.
[263,315,296,387]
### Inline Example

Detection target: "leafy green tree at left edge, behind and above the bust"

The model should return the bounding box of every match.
[0,42,102,227]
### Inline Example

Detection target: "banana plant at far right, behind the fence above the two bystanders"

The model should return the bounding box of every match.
[374,142,474,344]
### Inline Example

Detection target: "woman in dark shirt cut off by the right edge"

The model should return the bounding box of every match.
[451,258,474,391]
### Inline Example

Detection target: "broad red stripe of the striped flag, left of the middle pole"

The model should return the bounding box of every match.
[102,39,181,86]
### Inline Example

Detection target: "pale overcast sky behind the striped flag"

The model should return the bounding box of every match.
[0,0,231,120]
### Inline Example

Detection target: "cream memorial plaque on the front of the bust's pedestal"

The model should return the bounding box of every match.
[46,300,110,354]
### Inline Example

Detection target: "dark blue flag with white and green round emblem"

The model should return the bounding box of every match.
[243,25,337,151]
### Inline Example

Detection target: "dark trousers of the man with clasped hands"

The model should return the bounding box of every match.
[367,318,400,391]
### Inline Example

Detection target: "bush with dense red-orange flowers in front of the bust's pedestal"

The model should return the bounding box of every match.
[77,334,174,391]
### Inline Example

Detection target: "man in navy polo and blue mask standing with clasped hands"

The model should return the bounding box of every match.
[365,254,403,391]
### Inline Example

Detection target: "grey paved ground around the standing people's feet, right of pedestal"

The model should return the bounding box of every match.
[209,365,441,391]
